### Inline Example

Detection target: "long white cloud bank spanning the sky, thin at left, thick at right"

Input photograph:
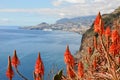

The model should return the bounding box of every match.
[0,0,120,19]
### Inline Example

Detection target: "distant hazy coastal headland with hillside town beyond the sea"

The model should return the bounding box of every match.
[22,16,95,34]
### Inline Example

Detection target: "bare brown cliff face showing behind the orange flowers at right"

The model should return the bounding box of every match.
[76,7,120,58]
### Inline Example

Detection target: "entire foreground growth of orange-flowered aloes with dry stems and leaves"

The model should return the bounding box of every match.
[6,13,120,80]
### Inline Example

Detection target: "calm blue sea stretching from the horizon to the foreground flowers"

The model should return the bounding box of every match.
[0,27,81,80]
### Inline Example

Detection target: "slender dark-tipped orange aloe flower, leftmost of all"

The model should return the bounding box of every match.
[6,56,14,80]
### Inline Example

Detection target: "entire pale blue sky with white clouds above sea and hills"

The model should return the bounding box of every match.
[0,0,120,26]
